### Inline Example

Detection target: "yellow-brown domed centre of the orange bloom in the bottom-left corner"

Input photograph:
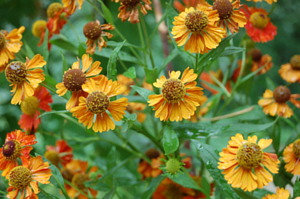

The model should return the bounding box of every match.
[8,166,31,189]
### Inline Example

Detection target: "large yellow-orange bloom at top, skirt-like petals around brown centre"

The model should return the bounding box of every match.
[172,5,226,54]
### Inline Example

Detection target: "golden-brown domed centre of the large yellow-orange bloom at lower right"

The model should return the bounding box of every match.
[237,142,263,169]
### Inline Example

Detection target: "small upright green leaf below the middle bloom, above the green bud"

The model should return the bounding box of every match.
[162,126,179,155]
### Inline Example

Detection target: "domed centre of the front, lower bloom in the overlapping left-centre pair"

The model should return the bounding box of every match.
[86,91,109,114]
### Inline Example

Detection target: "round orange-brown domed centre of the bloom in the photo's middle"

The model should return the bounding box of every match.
[162,79,185,102]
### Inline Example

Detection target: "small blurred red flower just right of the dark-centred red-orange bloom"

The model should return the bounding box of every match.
[44,140,73,167]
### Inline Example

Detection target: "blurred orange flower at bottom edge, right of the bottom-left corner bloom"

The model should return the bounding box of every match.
[65,160,100,199]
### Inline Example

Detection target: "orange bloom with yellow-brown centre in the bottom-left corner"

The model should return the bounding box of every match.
[7,156,52,199]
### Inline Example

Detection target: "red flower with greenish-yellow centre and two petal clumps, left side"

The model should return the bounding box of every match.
[18,86,52,133]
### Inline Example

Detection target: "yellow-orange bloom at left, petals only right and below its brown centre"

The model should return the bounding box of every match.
[5,54,46,104]
